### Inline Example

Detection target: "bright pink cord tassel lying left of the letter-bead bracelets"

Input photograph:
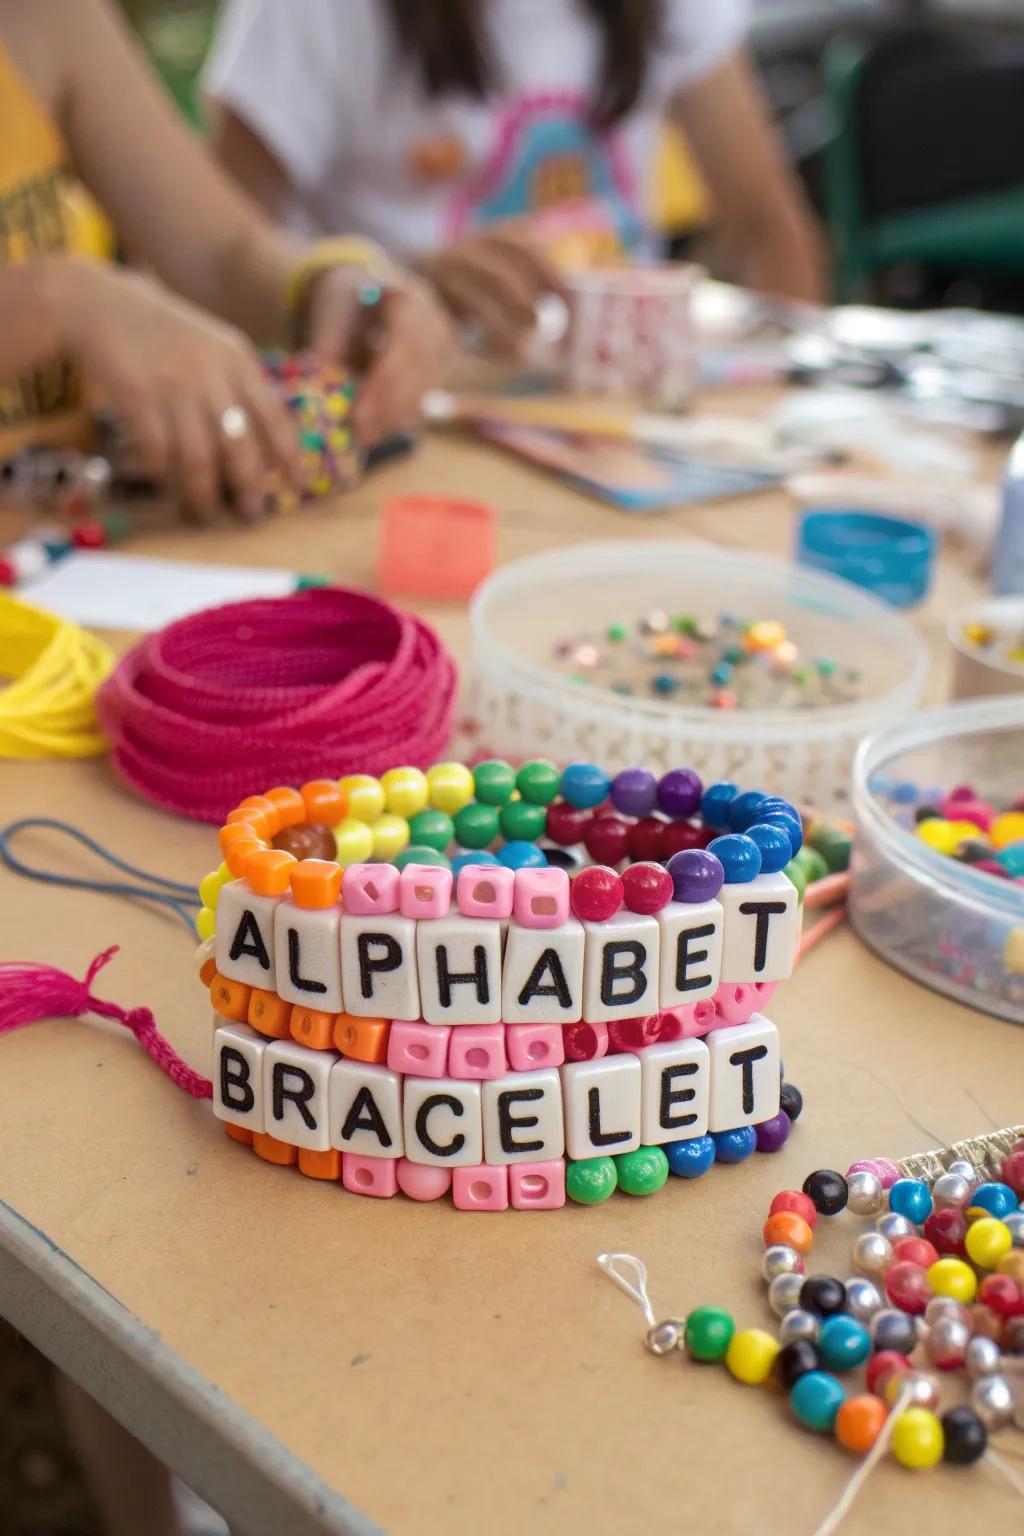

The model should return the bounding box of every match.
[0,945,213,1098]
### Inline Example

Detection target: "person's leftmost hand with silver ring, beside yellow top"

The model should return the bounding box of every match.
[55,261,299,519]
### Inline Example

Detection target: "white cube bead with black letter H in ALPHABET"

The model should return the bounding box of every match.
[417,912,502,1025]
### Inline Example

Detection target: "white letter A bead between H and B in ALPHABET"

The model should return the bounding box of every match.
[502,917,585,1025]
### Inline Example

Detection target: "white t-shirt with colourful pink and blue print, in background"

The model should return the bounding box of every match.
[206,0,749,257]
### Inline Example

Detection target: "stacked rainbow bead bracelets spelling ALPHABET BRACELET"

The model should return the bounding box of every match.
[197,760,803,1210]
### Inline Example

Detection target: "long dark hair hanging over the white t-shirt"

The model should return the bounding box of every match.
[388,0,665,127]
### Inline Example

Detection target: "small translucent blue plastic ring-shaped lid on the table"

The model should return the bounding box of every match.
[797,507,935,608]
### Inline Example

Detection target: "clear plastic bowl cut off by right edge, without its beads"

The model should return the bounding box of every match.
[847,696,1024,1025]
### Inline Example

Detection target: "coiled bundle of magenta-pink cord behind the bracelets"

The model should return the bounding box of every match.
[97,587,456,822]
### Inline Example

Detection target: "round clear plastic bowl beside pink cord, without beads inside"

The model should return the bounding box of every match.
[470,539,927,811]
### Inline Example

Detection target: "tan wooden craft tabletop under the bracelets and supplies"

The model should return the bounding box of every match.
[0,393,1024,1536]
